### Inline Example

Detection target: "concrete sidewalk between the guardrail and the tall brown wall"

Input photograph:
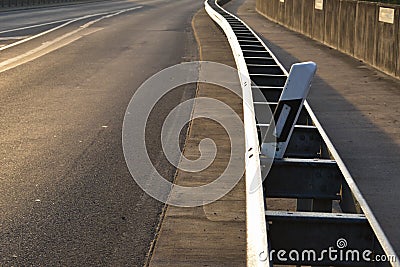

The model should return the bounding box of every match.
[224,0,400,254]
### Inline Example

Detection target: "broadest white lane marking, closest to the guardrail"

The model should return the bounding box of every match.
[0,6,141,73]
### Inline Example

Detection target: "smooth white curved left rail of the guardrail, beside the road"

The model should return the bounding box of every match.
[205,1,269,266]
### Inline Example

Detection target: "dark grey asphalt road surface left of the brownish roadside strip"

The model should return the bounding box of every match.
[0,0,202,266]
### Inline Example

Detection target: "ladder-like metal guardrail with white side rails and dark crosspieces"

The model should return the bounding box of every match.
[205,0,400,266]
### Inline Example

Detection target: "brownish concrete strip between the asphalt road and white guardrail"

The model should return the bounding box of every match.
[148,10,246,266]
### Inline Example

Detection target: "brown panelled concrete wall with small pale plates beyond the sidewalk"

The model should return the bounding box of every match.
[257,0,400,77]
